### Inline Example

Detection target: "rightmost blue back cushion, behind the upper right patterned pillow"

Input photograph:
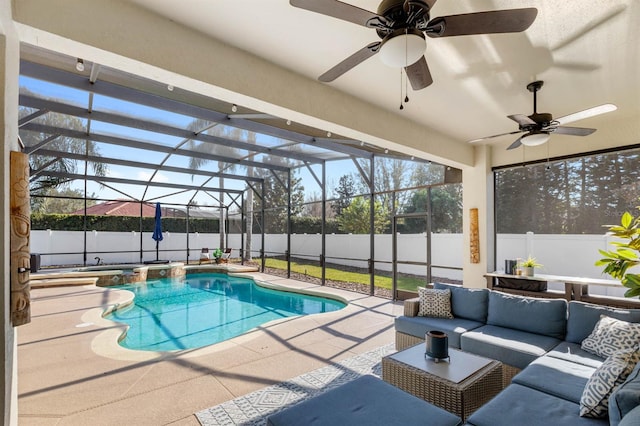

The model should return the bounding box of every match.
[565,301,640,343]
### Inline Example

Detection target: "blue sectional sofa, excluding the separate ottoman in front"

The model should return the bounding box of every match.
[395,283,640,426]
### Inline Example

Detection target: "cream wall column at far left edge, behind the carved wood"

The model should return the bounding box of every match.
[0,0,20,425]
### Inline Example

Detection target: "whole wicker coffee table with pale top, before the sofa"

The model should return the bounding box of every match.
[382,343,502,420]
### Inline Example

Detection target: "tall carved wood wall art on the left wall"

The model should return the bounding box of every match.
[9,151,31,327]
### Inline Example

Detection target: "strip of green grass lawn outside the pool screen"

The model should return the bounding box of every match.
[265,258,426,291]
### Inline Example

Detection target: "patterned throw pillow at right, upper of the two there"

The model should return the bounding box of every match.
[582,315,640,358]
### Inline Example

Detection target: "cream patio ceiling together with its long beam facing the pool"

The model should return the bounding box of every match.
[14,0,640,167]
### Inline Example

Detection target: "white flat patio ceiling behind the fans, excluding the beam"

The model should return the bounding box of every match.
[131,0,640,152]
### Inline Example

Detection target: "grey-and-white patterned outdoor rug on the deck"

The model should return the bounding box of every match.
[196,344,395,426]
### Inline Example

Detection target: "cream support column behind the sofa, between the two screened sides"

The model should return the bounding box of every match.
[462,146,495,287]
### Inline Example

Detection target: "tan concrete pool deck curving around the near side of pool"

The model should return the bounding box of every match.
[17,273,402,425]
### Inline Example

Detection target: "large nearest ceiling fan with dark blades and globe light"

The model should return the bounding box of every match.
[290,0,538,90]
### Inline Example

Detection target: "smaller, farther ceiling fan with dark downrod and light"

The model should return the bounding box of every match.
[469,81,617,149]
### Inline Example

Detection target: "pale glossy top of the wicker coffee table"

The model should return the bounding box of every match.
[387,343,493,383]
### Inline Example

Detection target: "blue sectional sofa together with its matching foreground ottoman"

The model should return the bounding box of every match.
[268,283,640,426]
